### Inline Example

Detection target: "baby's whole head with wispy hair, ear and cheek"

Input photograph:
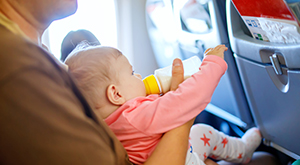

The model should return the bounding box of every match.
[65,45,146,118]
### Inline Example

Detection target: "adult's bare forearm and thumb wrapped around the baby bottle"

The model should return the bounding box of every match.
[145,59,194,165]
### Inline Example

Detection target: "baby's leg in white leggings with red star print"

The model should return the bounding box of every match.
[190,124,261,163]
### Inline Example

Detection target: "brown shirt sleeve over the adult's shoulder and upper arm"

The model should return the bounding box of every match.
[0,25,130,164]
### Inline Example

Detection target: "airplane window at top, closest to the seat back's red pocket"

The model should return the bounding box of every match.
[180,0,212,34]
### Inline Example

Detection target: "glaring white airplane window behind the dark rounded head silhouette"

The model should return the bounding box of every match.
[47,0,117,59]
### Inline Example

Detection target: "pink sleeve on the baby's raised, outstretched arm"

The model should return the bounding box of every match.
[124,55,227,134]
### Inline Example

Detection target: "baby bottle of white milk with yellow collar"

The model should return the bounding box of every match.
[143,56,201,95]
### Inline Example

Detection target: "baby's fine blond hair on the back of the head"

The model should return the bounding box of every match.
[65,43,122,108]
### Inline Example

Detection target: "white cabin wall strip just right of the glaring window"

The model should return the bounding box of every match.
[115,0,158,77]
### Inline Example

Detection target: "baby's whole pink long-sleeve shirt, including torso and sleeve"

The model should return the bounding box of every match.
[105,55,227,164]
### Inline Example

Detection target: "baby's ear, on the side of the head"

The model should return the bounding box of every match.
[106,84,126,105]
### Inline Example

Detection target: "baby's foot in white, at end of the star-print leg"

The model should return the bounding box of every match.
[242,127,262,163]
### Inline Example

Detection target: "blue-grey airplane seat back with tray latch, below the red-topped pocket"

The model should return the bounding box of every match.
[226,0,300,159]
